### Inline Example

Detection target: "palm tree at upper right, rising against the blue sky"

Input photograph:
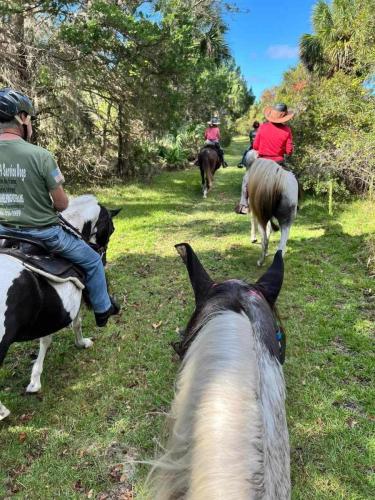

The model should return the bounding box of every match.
[299,0,357,76]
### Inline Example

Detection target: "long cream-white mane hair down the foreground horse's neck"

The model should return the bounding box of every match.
[148,311,264,500]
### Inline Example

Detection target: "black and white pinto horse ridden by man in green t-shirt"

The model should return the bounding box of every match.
[0,195,119,420]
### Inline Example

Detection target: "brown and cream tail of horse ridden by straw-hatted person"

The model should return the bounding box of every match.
[248,159,287,231]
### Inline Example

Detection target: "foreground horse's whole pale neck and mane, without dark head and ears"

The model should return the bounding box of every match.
[148,311,290,500]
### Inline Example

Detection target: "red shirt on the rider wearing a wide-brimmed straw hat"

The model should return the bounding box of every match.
[253,122,293,161]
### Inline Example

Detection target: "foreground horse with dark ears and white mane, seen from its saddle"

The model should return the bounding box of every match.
[148,243,291,500]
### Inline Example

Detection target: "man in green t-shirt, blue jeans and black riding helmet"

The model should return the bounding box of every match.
[0,88,119,326]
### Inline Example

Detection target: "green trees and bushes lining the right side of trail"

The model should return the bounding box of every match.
[239,0,375,194]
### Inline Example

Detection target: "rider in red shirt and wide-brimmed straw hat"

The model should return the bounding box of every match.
[235,103,294,214]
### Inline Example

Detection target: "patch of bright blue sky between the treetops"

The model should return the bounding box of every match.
[225,0,316,98]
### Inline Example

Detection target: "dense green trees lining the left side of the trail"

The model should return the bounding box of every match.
[0,0,253,181]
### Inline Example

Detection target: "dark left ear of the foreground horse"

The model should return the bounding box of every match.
[175,243,214,305]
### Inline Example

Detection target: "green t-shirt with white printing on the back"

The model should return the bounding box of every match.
[0,139,64,227]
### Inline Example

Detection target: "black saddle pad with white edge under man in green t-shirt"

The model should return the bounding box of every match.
[0,234,85,290]
